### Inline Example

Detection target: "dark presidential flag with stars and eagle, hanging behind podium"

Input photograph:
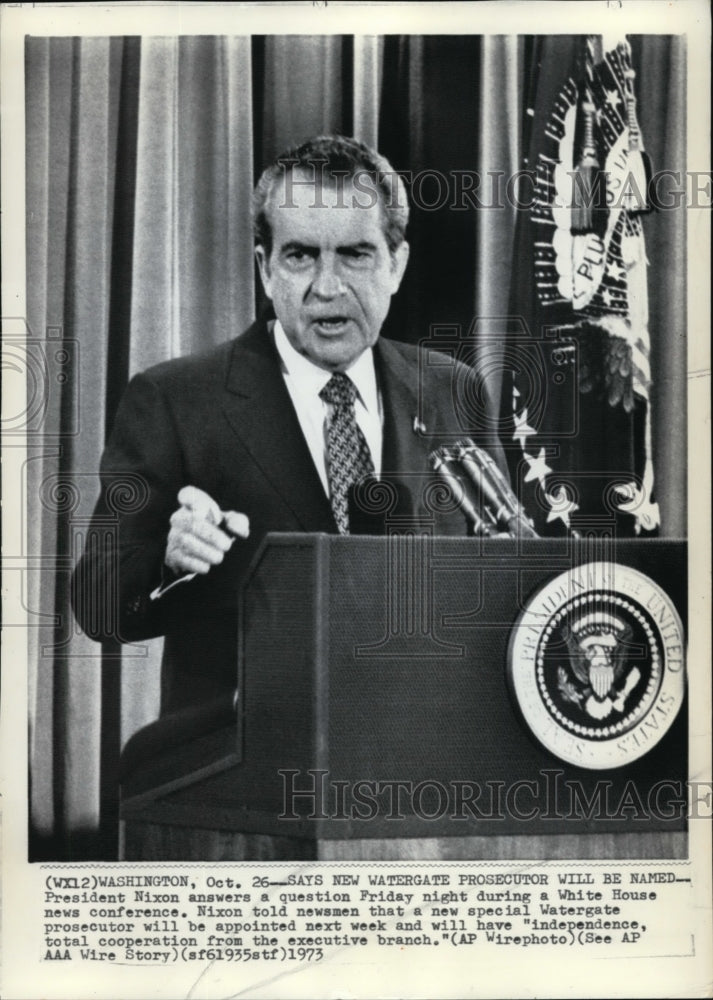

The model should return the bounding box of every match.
[501,35,659,536]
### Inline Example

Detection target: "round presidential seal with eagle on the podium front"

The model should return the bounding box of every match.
[508,562,685,769]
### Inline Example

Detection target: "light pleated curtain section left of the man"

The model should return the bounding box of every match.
[26,38,254,857]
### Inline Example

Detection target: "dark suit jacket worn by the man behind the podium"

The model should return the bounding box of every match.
[73,323,504,712]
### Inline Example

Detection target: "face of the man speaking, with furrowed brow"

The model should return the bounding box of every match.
[256,172,408,371]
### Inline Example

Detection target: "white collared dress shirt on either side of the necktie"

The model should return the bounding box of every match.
[273,320,383,496]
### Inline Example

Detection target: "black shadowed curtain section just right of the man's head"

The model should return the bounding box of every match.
[379,35,481,343]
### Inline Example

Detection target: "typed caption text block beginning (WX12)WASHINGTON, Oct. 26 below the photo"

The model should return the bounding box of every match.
[36,862,694,966]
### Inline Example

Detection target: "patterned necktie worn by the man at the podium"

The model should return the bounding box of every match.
[319,372,374,535]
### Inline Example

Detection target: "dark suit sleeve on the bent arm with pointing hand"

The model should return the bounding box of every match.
[72,375,190,642]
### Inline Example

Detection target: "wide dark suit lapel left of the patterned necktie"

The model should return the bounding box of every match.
[224,323,336,532]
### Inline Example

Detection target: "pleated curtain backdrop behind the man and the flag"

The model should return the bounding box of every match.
[24,36,685,859]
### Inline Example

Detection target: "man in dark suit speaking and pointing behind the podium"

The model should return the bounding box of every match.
[73,137,504,712]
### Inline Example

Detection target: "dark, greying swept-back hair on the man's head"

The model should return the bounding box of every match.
[252,135,409,255]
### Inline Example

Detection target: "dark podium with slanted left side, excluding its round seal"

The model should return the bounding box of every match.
[121,535,687,860]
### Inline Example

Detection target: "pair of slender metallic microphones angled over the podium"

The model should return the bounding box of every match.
[431,438,539,538]
